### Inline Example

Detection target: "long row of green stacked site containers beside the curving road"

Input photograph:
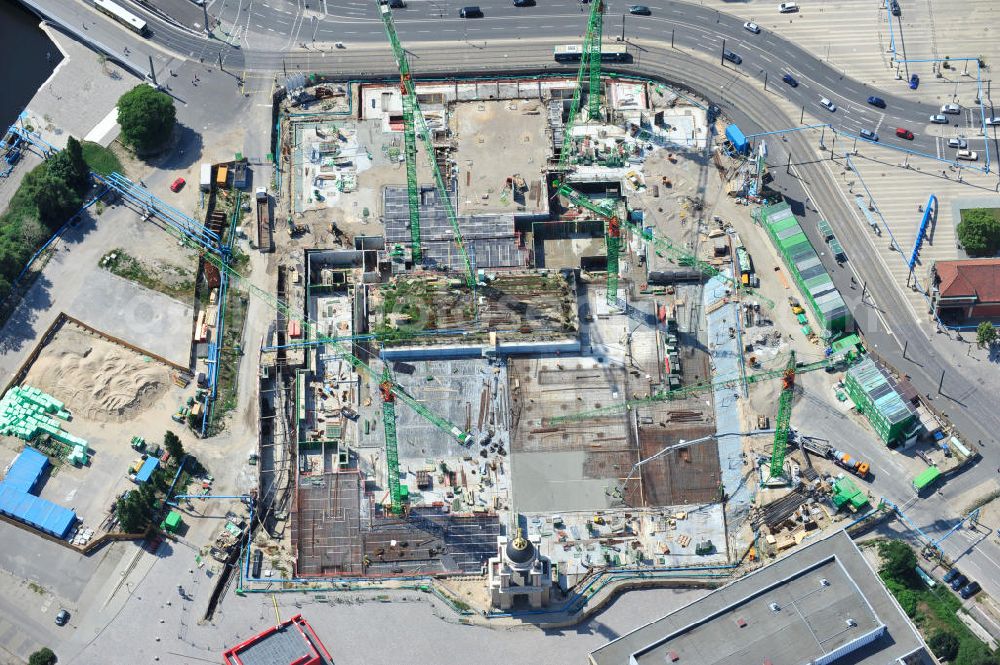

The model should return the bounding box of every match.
[759,203,852,339]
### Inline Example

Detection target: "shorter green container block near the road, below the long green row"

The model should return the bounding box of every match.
[844,358,917,445]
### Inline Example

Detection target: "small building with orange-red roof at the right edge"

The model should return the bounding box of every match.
[931,259,1000,321]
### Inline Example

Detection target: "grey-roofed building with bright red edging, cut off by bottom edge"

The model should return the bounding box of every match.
[222,614,333,665]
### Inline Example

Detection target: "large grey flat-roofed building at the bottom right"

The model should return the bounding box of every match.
[590,531,933,665]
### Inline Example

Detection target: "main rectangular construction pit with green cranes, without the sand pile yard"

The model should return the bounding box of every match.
[230,1,948,609]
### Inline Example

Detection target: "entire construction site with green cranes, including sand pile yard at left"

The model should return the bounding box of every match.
[0,3,976,628]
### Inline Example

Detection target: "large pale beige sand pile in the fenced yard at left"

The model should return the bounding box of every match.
[24,324,170,422]
